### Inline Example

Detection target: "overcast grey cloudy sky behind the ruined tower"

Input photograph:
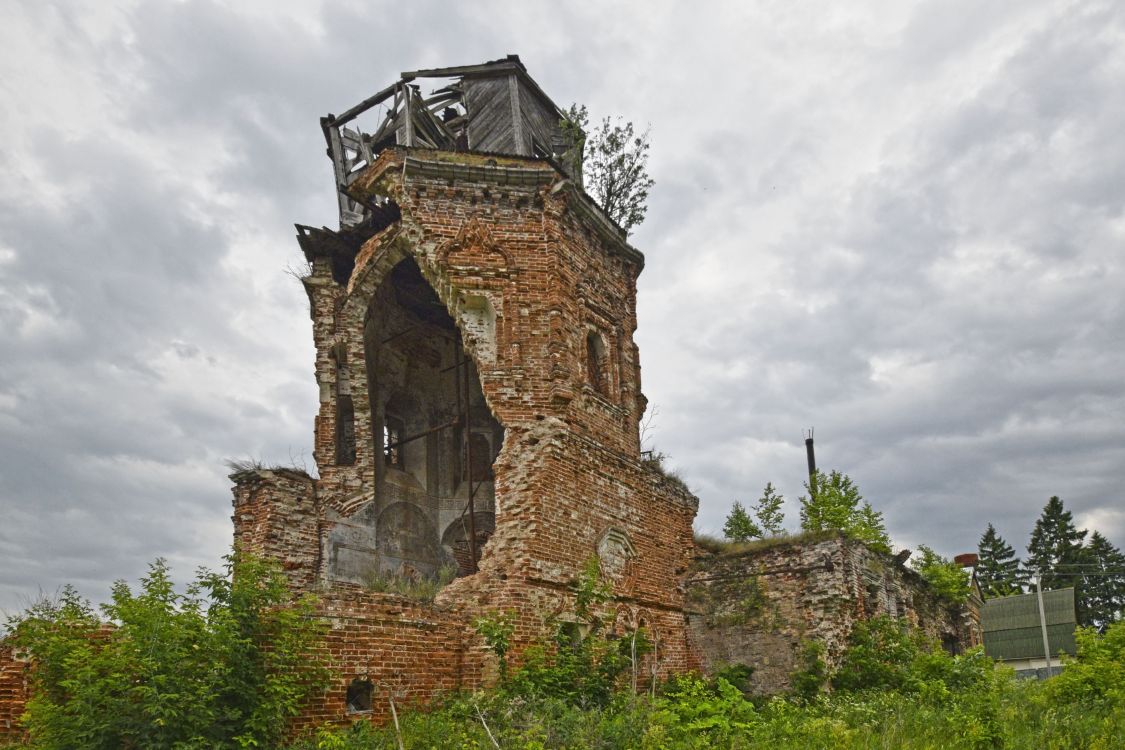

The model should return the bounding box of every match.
[0,0,1125,611]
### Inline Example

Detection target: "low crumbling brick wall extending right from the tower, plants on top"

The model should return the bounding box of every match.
[687,534,980,694]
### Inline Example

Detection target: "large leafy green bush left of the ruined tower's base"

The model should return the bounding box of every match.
[8,557,327,750]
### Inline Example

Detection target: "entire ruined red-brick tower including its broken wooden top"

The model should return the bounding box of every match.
[232,55,698,719]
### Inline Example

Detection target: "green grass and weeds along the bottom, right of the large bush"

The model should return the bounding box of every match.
[285,622,1125,750]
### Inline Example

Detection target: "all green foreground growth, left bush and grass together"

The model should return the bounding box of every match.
[7,558,1125,750]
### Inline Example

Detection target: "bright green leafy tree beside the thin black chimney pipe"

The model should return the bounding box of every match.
[799,470,891,552]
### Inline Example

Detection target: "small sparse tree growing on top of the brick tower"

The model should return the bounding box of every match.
[561,105,654,233]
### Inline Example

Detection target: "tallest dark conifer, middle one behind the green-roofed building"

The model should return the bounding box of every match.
[1024,495,1090,625]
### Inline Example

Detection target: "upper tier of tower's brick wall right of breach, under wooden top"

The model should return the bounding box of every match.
[349,150,642,455]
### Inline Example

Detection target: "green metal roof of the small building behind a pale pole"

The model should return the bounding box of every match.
[981,588,1076,660]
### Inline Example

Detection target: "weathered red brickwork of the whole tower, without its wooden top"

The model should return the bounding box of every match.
[234,148,699,724]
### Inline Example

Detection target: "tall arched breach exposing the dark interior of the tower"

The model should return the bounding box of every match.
[365,259,504,576]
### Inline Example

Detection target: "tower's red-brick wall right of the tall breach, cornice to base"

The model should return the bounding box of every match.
[344,150,698,669]
